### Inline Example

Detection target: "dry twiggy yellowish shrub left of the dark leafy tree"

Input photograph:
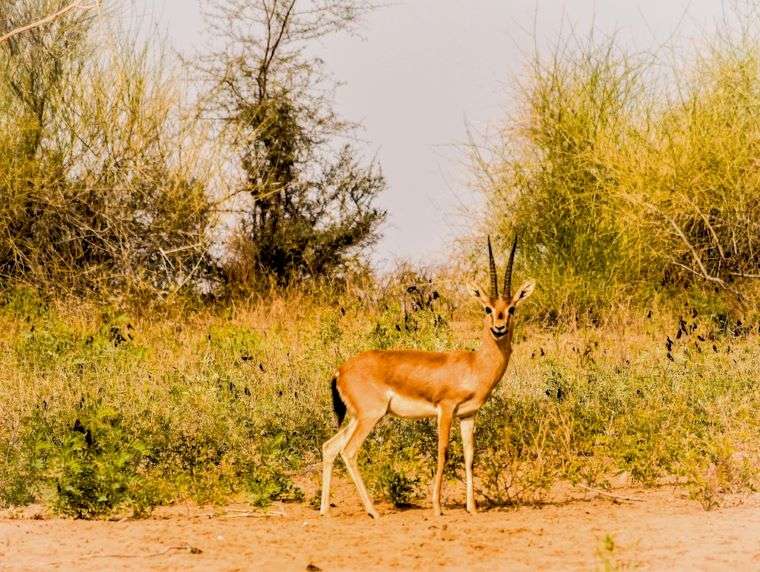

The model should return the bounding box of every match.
[0,2,213,297]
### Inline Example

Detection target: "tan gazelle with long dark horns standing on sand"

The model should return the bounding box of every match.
[320,237,535,518]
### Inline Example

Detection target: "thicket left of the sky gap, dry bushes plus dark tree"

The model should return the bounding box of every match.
[0,0,385,302]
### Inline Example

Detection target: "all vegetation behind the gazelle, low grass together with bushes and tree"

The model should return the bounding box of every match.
[0,0,760,518]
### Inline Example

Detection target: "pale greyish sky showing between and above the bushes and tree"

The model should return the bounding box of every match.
[126,0,728,268]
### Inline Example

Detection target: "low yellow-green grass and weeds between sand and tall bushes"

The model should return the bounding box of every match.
[0,283,760,517]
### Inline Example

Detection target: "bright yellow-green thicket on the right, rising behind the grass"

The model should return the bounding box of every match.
[480,34,760,317]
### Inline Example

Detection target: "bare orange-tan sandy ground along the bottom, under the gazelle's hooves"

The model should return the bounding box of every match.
[0,482,760,571]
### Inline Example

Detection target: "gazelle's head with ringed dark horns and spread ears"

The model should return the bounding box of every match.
[470,236,536,342]
